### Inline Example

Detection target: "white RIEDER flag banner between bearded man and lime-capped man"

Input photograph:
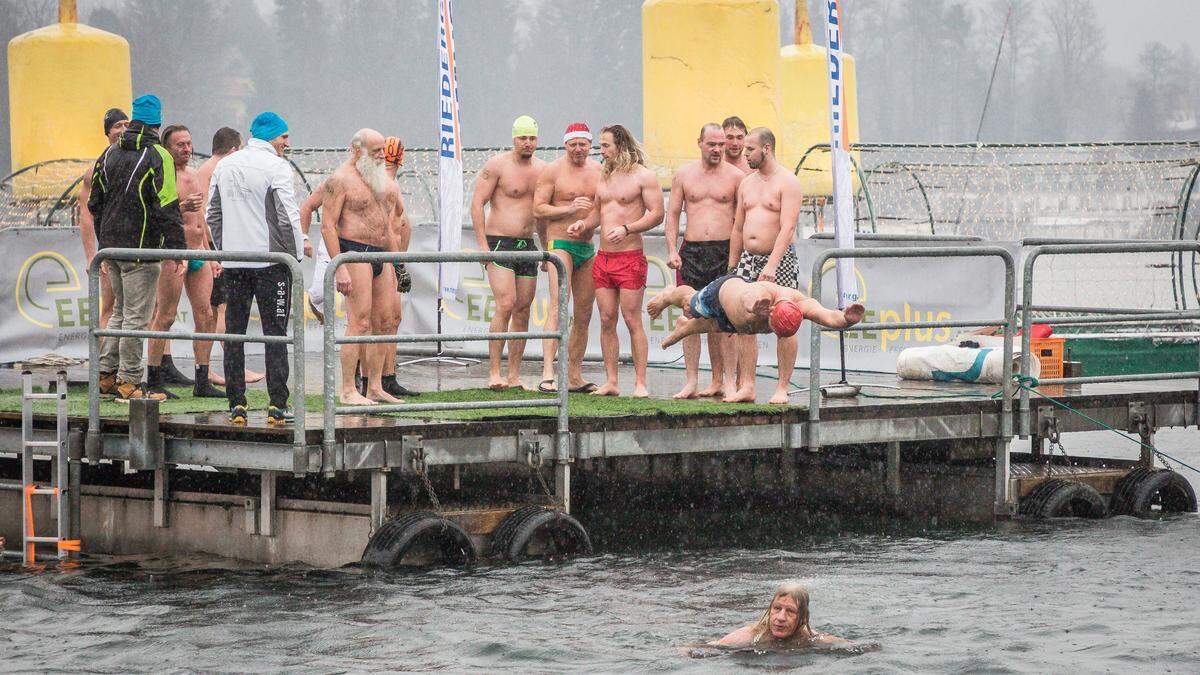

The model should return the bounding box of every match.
[438,0,463,298]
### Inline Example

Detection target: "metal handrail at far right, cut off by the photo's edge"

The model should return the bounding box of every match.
[1019,240,1200,438]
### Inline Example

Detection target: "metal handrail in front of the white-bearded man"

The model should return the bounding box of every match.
[323,251,570,461]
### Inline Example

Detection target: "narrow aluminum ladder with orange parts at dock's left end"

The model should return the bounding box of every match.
[20,370,79,565]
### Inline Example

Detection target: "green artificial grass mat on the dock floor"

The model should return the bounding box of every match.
[0,387,799,420]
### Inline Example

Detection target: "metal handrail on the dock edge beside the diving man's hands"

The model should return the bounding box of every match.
[806,246,1016,450]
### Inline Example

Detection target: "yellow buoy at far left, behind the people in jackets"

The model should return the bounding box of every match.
[8,0,133,183]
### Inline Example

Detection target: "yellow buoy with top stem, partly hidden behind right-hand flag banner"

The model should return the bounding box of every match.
[779,11,859,197]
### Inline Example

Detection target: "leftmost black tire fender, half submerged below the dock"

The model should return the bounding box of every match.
[362,510,476,568]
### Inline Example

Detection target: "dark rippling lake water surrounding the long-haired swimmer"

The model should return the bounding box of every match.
[7,432,1200,673]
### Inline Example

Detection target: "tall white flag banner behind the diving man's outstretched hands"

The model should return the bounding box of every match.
[826,0,858,307]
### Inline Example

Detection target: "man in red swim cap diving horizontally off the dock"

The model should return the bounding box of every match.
[646,274,865,348]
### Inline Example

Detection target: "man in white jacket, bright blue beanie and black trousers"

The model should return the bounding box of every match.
[206,112,304,425]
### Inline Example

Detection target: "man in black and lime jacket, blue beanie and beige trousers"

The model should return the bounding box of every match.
[88,94,186,402]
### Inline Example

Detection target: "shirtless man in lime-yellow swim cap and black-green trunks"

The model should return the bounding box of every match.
[470,115,554,389]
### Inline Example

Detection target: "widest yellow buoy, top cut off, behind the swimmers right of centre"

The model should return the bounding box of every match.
[642,0,786,180]
